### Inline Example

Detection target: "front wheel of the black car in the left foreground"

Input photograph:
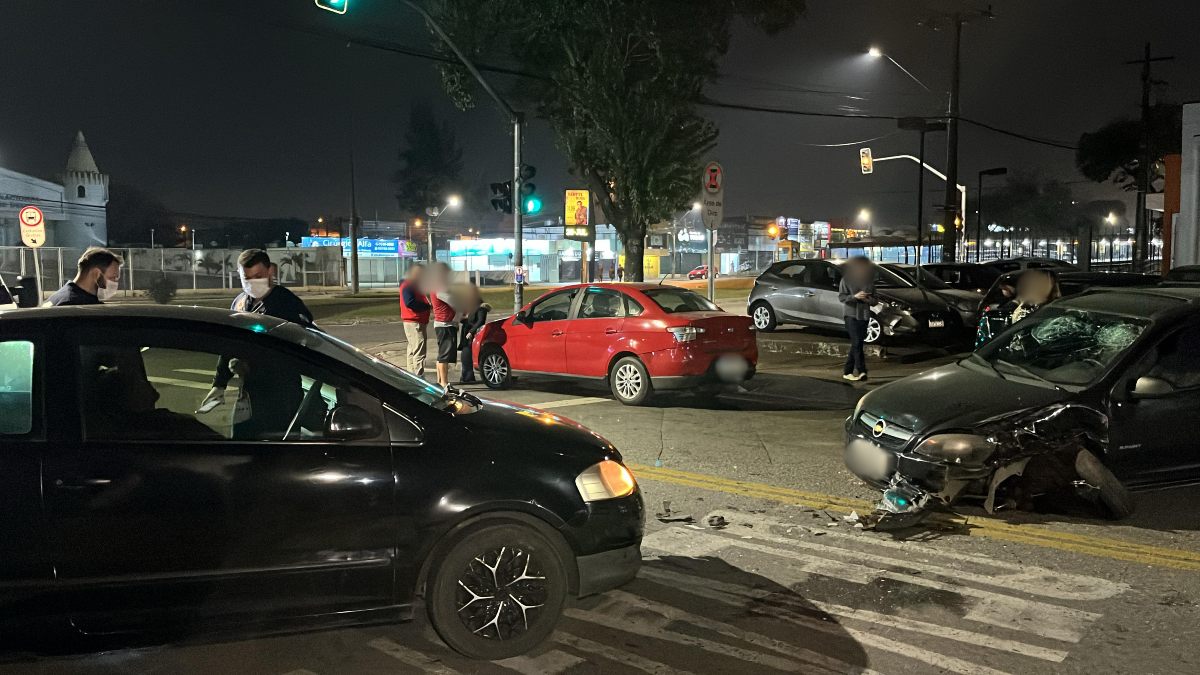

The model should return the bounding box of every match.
[425,522,569,661]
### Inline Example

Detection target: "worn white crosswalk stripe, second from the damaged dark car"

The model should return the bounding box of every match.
[642,527,1100,643]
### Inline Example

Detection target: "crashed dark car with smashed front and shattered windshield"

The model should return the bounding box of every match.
[845,288,1200,526]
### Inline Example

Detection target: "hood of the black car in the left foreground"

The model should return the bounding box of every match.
[458,400,620,464]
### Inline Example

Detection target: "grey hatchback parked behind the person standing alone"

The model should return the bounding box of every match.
[746,259,964,344]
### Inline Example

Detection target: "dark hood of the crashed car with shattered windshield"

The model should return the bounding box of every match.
[860,363,1070,435]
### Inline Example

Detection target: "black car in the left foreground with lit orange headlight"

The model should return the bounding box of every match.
[0,305,643,659]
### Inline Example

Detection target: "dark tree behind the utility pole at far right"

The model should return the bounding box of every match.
[1075,103,1183,191]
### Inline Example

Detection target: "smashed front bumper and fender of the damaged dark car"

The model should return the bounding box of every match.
[845,404,1108,524]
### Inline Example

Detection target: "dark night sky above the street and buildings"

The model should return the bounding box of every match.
[0,0,1200,227]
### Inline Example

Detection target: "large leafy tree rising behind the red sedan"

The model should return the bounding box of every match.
[433,0,804,281]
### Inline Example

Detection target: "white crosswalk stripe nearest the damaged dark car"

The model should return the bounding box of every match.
[706,512,1129,601]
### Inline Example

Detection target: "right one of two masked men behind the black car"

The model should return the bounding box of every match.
[197,249,316,437]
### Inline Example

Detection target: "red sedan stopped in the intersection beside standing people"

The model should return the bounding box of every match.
[474,283,758,405]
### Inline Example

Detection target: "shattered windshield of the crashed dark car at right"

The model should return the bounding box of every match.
[974,305,1150,387]
